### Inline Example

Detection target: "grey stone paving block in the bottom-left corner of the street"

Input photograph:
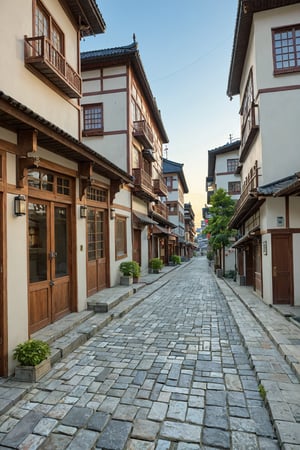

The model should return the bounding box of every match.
[1,411,43,448]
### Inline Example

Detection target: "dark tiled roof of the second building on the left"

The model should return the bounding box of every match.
[81,41,169,144]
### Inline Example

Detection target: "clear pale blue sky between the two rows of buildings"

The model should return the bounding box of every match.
[81,0,240,226]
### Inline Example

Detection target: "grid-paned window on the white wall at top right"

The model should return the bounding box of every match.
[272,25,300,74]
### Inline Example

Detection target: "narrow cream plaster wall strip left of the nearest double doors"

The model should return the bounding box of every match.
[6,194,28,373]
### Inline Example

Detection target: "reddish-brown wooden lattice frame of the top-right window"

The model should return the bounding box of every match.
[272,24,300,75]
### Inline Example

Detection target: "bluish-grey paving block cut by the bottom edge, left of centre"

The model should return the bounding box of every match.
[96,419,132,450]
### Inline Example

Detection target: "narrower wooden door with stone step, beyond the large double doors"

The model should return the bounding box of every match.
[87,207,108,296]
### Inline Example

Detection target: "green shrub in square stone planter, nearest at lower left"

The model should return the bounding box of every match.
[13,339,51,383]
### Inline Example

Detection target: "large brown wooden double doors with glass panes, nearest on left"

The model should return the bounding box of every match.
[28,200,71,334]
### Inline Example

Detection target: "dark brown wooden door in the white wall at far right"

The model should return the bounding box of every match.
[272,234,294,305]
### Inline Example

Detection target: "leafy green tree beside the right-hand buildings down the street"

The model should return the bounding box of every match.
[204,189,236,270]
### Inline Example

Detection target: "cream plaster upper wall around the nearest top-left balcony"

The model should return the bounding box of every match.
[0,0,79,138]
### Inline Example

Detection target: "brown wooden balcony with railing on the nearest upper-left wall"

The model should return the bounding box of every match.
[24,36,82,98]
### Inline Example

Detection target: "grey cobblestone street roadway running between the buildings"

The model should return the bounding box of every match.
[0,258,299,450]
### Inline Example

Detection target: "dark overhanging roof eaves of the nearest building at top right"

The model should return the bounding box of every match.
[227,0,299,97]
